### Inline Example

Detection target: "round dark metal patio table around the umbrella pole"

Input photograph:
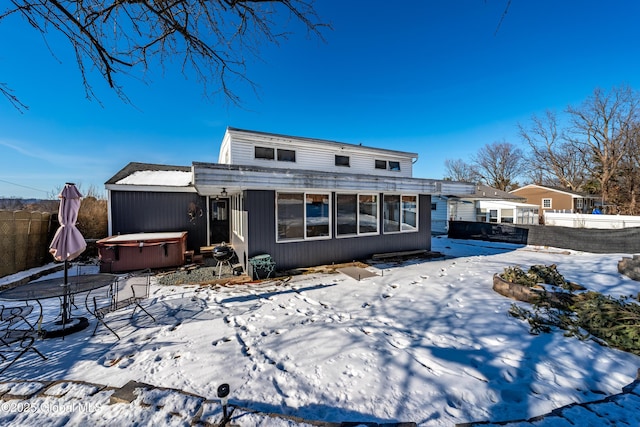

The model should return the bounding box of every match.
[0,274,118,338]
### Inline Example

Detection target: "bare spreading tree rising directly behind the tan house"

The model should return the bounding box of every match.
[518,111,588,191]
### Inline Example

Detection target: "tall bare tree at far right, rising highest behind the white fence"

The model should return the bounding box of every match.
[567,86,640,209]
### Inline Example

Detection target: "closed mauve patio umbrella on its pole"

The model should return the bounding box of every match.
[49,183,87,328]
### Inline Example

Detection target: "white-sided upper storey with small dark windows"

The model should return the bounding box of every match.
[218,128,418,178]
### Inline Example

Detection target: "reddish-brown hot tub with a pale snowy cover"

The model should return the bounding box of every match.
[96,231,187,273]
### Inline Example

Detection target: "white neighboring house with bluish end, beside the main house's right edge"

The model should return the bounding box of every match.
[431,184,538,234]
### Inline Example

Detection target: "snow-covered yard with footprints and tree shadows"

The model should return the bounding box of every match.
[4,237,640,426]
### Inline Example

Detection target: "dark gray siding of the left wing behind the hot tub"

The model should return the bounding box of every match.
[110,191,207,250]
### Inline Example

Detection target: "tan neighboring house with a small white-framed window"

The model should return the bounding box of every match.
[511,184,599,215]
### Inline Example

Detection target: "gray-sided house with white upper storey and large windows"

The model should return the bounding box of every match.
[105,128,475,271]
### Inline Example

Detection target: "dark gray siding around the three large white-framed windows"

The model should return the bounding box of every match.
[245,190,431,270]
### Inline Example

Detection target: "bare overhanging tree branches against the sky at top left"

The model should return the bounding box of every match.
[0,0,328,109]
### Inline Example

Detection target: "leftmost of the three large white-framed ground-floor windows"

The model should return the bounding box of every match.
[276,193,331,242]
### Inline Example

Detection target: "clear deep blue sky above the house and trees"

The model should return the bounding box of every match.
[0,0,640,198]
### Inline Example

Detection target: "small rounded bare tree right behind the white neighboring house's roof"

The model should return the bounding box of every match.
[473,142,524,191]
